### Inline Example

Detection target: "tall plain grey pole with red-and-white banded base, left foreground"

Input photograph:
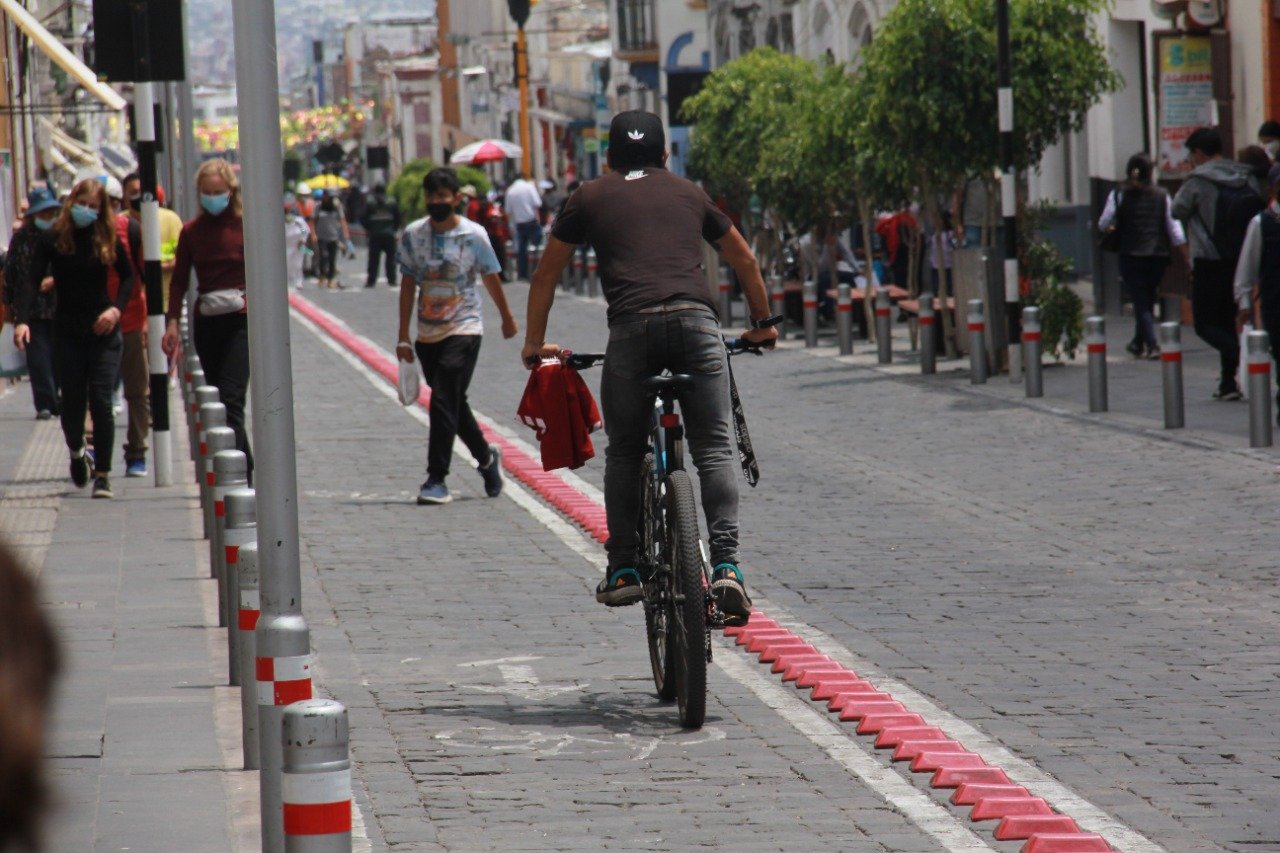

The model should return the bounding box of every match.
[232,0,312,835]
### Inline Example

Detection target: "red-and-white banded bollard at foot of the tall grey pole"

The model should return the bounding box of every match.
[253,612,311,853]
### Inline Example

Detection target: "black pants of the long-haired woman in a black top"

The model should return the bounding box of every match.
[54,329,124,474]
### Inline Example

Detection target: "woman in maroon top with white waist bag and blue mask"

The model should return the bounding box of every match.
[163,159,252,473]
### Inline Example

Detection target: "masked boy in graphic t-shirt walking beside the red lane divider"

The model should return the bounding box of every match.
[396,168,517,503]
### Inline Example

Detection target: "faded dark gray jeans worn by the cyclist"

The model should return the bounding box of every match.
[600,306,739,571]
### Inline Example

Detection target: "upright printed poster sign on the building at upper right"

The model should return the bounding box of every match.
[1156,35,1216,179]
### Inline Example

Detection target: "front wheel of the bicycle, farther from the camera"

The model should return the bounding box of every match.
[636,453,676,702]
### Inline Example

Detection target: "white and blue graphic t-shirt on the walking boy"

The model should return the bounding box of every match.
[399,218,502,343]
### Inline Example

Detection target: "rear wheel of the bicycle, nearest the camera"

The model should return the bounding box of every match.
[663,470,707,729]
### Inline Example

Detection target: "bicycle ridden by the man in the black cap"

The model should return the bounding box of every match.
[561,330,772,729]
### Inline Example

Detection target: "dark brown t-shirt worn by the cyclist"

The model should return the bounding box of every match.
[552,167,733,321]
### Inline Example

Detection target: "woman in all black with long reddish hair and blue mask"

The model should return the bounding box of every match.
[14,178,134,498]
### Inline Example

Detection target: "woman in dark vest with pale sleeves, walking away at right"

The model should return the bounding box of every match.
[1098,154,1190,359]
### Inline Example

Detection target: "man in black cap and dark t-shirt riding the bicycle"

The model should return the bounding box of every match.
[521,110,778,619]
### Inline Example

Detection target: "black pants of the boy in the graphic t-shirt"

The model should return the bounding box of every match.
[413,334,489,483]
